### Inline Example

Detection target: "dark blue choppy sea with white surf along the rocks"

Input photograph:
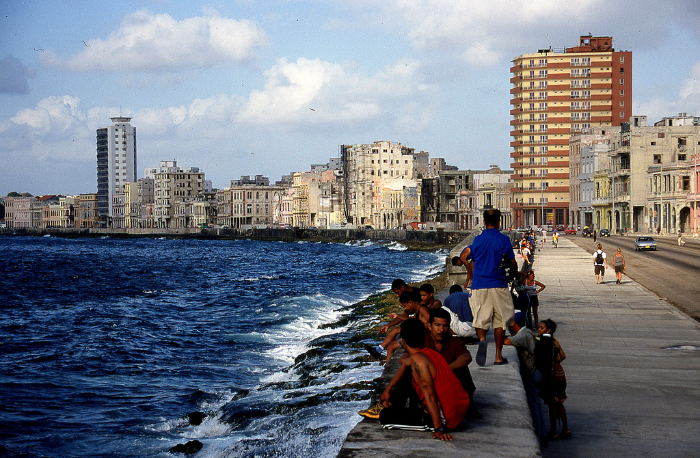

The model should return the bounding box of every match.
[0,237,445,457]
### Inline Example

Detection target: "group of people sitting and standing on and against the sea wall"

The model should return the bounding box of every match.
[360,210,571,445]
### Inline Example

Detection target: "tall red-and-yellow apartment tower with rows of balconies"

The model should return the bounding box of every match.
[510,35,632,226]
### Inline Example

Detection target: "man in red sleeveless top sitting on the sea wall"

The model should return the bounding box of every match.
[379,318,470,440]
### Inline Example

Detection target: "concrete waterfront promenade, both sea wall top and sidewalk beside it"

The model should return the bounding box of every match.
[339,237,700,458]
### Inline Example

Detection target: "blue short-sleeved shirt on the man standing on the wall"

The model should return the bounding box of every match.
[469,229,515,289]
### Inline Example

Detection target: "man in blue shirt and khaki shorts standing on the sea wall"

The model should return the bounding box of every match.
[452,210,518,366]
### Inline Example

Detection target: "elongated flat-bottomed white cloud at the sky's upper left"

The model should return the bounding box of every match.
[40,10,268,72]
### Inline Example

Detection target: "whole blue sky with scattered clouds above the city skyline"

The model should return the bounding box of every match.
[0,0,700,196]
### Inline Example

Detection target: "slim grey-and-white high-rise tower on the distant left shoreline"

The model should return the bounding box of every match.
[97,116,136,225]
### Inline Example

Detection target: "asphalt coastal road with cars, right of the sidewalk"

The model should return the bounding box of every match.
[566,235,700,321]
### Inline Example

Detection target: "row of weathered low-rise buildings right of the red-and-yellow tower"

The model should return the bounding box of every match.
[570,113,700,233]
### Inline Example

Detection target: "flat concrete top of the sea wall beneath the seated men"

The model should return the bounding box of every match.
[338,242,541,458]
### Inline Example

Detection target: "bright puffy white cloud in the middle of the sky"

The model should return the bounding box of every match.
[237,58,433,127]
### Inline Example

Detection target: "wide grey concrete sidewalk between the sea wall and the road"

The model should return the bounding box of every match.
[533,236,700,458]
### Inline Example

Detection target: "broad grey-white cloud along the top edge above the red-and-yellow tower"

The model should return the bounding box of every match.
[360,0,700,66]
